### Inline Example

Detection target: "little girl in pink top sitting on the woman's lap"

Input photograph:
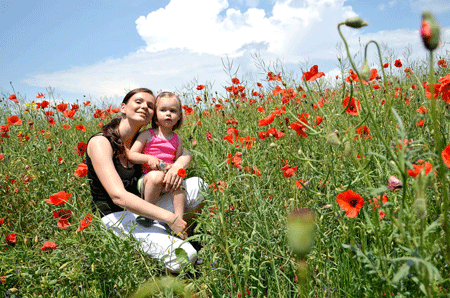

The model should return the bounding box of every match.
[128,92,186,239]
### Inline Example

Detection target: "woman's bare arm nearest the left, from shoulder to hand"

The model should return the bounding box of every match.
[87,136,186,233]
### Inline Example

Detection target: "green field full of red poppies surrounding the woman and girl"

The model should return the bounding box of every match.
[0,18,450,297]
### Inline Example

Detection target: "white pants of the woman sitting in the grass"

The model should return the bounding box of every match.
[102,177,205,272]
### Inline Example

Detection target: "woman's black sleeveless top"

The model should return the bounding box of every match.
[86,133,142,216]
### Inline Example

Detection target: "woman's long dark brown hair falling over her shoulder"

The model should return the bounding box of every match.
[101,88,153,158]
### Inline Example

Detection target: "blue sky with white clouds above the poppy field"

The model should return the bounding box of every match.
[0,0,450,102]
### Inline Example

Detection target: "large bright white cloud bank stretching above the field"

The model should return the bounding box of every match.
[22,0,450,96]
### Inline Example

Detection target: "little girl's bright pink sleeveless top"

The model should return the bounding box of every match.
[142,129,180,174]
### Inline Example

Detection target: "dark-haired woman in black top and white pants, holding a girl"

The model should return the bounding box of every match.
[86,88,203,271]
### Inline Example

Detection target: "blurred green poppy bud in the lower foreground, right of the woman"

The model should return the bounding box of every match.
[287,208,316,258]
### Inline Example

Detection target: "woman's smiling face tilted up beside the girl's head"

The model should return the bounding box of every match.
[120,92,155,125]
